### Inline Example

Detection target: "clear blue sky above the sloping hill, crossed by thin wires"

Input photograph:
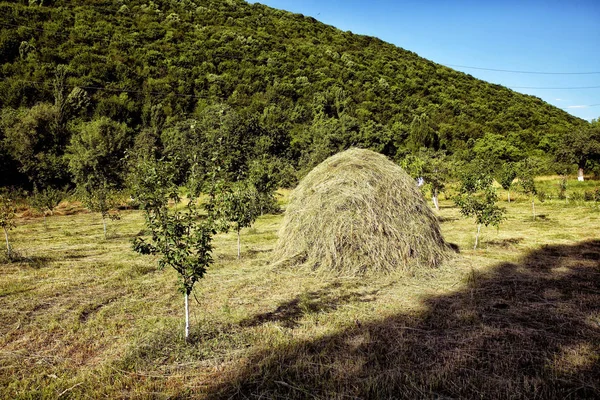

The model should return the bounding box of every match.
[251,0,600,120]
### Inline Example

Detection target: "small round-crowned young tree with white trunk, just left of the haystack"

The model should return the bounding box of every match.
[214,181,260,259]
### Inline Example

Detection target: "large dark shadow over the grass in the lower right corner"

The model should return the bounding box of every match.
[208,241,600,399]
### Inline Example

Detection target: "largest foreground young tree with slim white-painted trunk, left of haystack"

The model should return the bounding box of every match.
[131,159,216,340]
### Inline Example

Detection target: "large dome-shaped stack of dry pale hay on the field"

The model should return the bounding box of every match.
[274,149,448,275]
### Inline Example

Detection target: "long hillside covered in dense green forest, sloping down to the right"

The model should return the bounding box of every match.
[0,0,585,188]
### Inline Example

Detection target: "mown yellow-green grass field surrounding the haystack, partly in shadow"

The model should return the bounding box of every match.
[0,177,600,399]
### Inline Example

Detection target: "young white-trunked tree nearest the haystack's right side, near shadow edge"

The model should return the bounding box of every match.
[454,164,506,249]
